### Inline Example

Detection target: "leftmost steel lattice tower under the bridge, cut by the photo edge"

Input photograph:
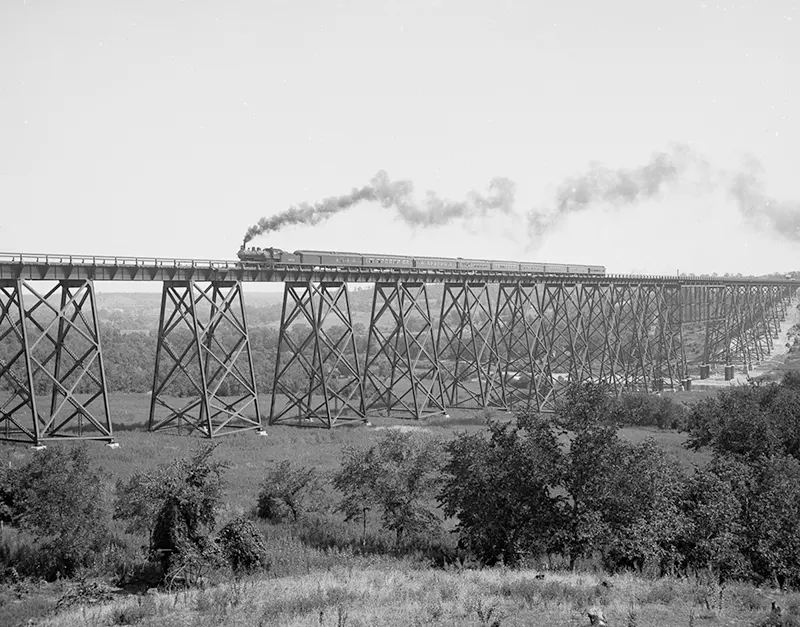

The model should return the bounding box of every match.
[0,280,114,446]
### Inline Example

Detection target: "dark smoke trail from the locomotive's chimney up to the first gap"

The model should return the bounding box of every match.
[244,170,516,243]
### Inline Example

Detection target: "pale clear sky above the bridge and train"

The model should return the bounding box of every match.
[0,0,800,290]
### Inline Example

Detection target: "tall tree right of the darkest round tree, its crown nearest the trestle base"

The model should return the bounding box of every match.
[554,382,684,569]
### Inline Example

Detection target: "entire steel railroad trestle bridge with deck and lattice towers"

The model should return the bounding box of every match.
[0,253,800,445]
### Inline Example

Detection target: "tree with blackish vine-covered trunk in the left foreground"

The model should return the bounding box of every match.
[114,444,227,579]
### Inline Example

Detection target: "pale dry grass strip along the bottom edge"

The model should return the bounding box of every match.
[23,559,798,627]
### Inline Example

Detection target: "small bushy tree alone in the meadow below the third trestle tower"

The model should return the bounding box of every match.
[256,460,322,522]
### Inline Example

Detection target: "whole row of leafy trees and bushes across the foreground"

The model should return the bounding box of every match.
[7,376,800,600]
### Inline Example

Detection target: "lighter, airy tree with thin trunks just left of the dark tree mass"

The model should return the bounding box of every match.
[333,430,442,548]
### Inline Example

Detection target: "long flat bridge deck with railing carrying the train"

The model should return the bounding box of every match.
[0,253,800,287]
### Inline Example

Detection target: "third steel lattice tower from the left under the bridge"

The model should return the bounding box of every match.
[269,282,364,428]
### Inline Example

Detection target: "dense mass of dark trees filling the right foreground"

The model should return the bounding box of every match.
[439,377,800,587]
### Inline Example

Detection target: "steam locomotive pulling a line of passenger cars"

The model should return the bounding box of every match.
[237,246,606,276]
